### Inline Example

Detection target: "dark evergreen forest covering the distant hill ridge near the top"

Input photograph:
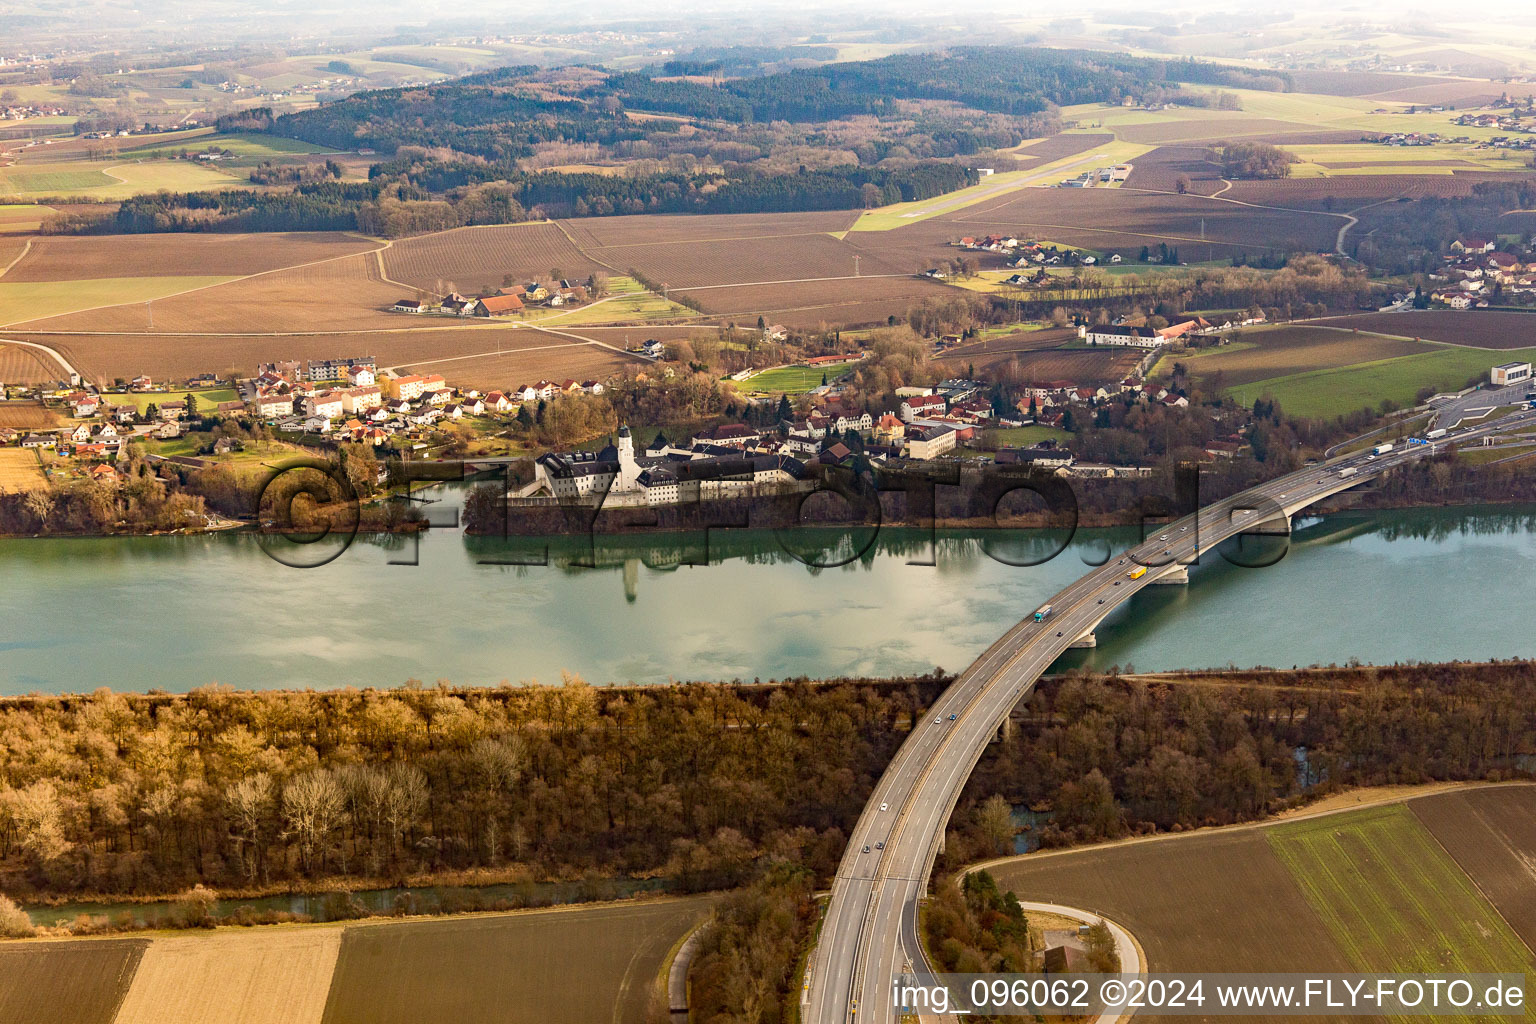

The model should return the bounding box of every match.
[267,46,1272,160]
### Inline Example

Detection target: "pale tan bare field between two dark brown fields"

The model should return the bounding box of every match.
[114,926,343,1024]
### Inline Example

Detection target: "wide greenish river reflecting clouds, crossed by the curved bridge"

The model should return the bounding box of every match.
[0,507,1536,694]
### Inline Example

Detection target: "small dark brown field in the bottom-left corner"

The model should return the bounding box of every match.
[0,938,149,1024]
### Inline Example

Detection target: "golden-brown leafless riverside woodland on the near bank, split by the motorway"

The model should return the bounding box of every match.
[0,662,1536,898]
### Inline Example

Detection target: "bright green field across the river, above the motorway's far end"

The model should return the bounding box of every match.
[1226,347,1536,419]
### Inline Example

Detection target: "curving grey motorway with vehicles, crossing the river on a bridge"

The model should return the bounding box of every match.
[800,410,1536,1024]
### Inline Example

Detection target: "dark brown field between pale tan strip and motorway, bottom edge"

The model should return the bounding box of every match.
[323,897,713,1024]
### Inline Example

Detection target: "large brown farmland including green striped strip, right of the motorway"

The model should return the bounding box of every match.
[991,786,1536,1019]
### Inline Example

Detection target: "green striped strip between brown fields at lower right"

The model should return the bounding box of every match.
[1264,804,1536,982]
